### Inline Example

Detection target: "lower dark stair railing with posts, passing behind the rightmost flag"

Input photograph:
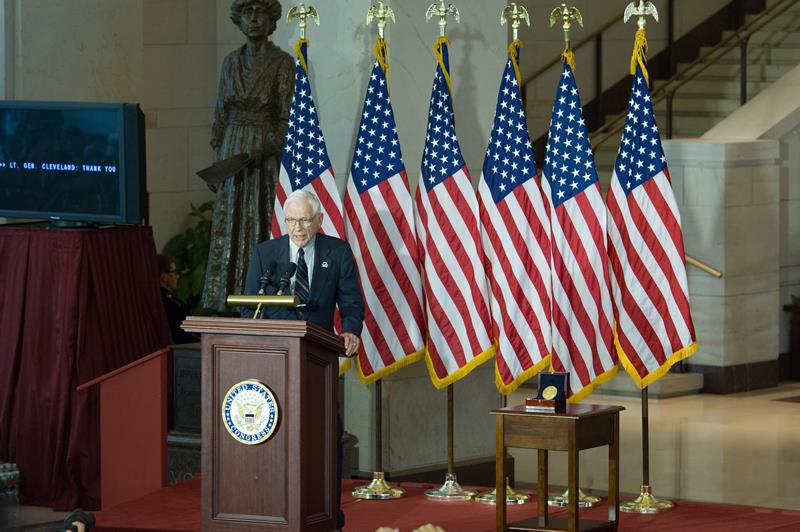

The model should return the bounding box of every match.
[591,0,800,150]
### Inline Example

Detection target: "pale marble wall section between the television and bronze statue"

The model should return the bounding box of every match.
[142,0,219,249]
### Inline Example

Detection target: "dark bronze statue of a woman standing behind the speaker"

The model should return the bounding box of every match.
[203,0,295,312]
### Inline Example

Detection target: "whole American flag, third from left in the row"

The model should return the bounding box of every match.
[416,38,494,388]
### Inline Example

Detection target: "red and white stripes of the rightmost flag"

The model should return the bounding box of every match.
[607,168,697,388]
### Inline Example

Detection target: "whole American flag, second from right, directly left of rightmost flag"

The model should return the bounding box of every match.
[542,61,617,401]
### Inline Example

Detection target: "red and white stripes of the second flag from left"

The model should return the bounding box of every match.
[344,170,424,384]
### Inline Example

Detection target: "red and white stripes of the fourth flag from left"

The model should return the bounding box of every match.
[478,178,552,394]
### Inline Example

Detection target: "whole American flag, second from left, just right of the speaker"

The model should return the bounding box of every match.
[344,44,424,383]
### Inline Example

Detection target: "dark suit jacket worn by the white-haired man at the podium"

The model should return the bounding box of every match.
[242,234,364,335]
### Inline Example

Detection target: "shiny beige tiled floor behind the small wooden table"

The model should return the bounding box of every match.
[508,382,800,510]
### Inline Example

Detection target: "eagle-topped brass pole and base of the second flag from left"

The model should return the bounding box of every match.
[351,1,406,500]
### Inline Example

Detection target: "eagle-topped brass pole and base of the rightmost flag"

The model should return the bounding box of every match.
[619,0,675,514]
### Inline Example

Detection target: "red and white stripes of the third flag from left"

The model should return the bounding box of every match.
[416,167,494,388]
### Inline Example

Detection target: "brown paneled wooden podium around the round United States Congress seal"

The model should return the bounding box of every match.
[183,316,344,532]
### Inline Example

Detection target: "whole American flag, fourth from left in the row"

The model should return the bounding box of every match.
[478,43,551,394]
